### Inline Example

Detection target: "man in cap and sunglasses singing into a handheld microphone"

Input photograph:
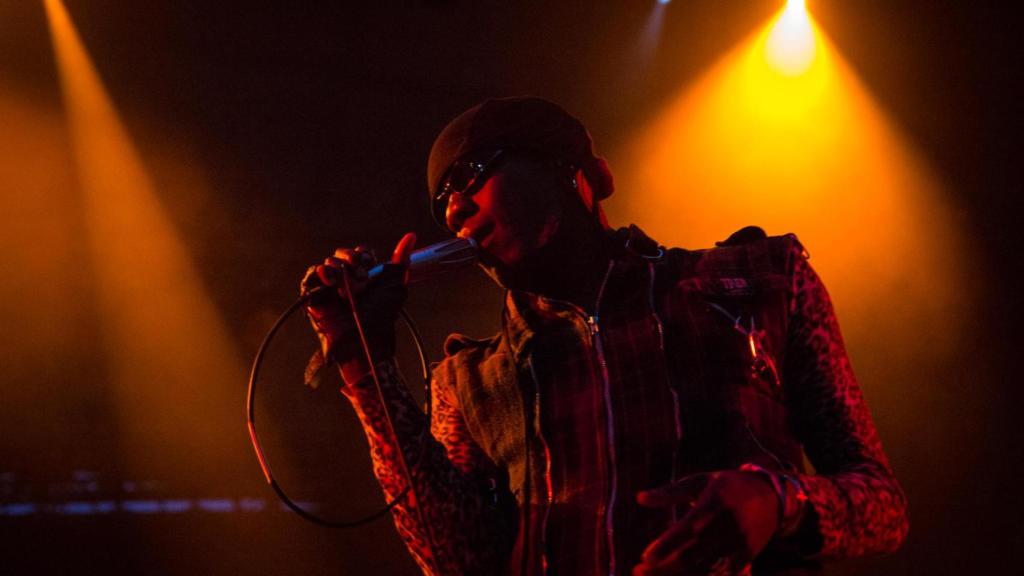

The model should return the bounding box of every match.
[303,97,907,576]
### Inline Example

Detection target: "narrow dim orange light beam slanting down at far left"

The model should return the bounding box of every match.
[45,0,255,483]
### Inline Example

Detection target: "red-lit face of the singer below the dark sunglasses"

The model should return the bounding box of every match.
[445,152,565,284]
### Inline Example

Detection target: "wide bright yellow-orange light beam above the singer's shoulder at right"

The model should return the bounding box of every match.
[607,2,973,446]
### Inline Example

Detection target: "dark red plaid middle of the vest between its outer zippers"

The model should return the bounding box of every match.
[507,255,681,574]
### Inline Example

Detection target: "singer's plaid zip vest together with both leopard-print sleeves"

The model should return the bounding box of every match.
[343,229,906,575]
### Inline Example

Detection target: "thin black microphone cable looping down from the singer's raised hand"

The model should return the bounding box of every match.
[246,266,433,524]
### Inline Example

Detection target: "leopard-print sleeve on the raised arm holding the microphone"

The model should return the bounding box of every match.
[342,361,515,575]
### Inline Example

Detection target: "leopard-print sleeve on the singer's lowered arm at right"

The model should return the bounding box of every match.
[784,245,908,559]
